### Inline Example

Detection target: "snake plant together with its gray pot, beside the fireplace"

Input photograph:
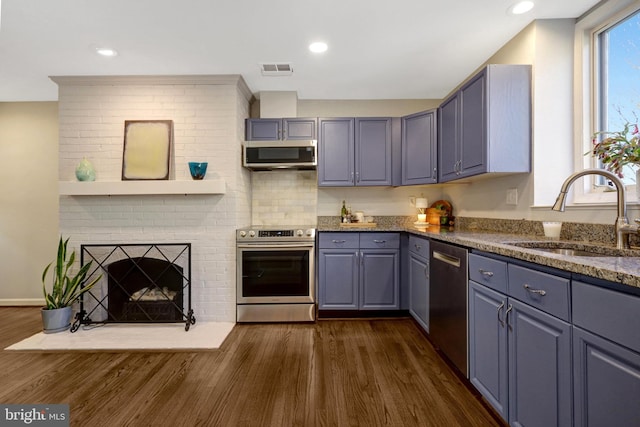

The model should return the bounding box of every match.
[42,236,102,333]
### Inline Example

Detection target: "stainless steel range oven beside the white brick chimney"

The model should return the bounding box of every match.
[236,227,315,322]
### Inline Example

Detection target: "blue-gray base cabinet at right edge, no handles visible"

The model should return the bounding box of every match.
[572,280,640,427]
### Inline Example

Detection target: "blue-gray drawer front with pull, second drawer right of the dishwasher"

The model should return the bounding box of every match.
[507,264,569,322]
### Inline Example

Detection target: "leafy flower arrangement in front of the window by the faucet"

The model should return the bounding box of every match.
[585,117,640,178]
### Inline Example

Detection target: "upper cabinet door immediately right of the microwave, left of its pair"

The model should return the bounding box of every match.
[318,118,355,187]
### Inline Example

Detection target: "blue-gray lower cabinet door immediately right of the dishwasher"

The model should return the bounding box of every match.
[469,281,509,420]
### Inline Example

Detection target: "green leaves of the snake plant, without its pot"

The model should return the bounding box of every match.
[42,236,102,310]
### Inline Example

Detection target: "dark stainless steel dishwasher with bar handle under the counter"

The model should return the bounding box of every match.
[429,240,469,378]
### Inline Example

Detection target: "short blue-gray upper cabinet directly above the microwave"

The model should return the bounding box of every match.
[245,117,317,141]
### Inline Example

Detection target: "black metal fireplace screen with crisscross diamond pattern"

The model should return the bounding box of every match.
[71,243,195,332]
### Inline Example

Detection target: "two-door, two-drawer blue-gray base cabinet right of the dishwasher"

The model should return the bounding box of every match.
[469,254,573,426]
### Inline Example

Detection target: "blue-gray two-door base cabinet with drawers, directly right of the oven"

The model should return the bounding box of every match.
[318,232,400,310]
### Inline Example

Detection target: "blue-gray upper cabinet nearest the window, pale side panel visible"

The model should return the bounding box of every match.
[438,64,531,182]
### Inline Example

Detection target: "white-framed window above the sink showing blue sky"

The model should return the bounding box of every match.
[573,0,640,204]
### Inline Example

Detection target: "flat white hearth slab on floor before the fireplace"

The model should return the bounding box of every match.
[5,322,234,350]
